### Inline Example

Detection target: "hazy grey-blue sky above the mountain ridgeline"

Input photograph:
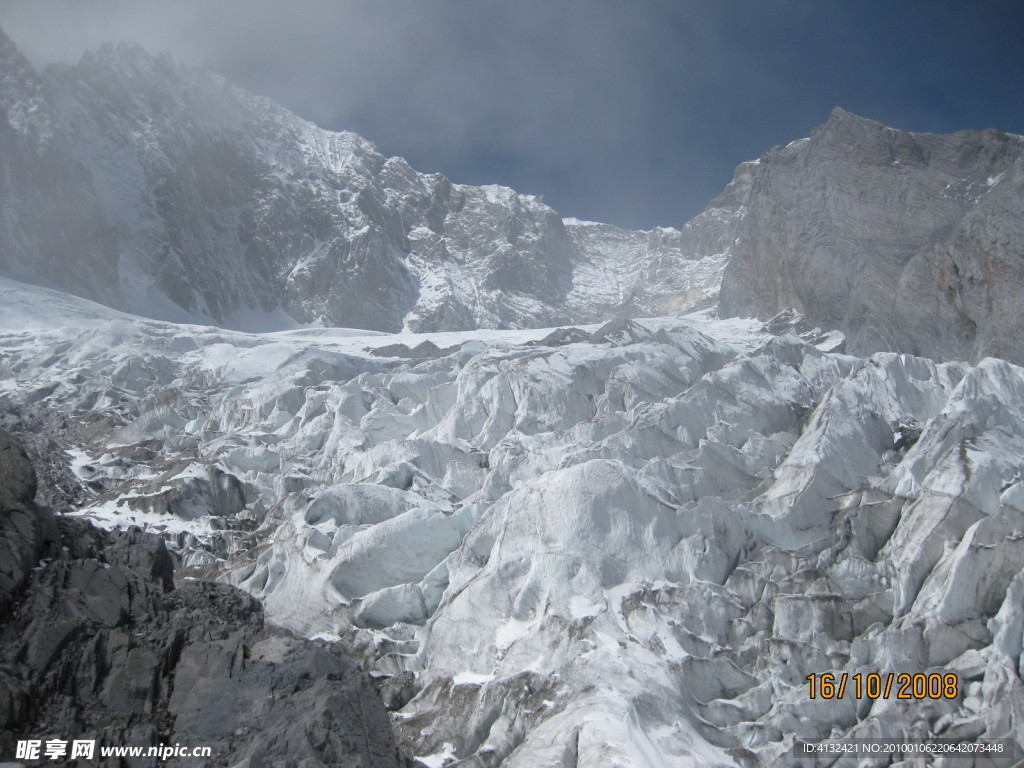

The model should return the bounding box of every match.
[0,0,1024,228]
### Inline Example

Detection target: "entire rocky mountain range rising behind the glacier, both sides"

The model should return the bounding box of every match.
[0,26,1024,354]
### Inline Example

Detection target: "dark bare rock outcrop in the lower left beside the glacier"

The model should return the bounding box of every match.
[0,430,407,768]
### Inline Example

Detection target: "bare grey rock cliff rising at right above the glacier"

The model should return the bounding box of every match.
[708,108,1024,362]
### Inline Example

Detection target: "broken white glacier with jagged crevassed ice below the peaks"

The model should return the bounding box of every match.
[0,281,1024,768]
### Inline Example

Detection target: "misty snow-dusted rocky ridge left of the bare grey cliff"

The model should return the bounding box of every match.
[0,27,722,331]
